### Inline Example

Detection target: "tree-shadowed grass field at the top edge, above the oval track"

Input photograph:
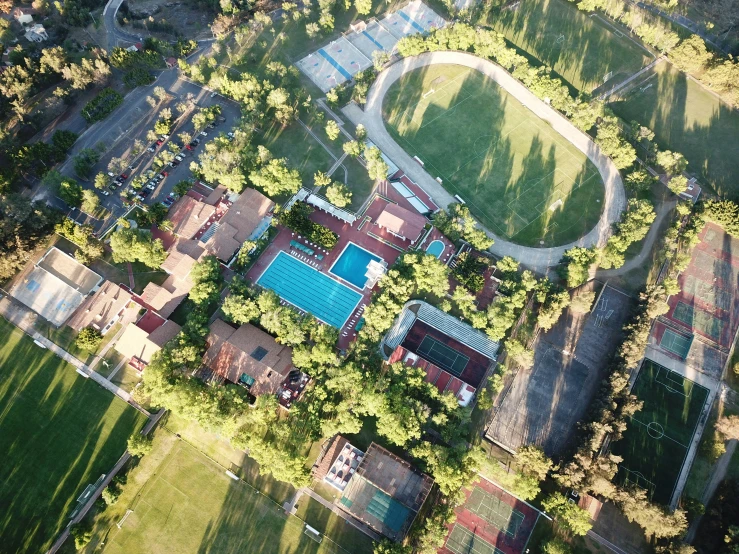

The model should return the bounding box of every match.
[479,0,653,92]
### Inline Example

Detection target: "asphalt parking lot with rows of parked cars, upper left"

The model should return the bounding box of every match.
[61,79,240,225]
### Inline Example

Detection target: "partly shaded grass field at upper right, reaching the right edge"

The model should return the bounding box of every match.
[611,61,739,199]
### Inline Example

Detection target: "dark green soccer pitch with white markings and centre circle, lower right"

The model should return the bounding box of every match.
[611,359,708,504]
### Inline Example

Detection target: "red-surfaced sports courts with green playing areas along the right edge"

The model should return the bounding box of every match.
[665,223,739,349]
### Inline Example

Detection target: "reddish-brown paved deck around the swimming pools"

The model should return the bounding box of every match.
[246,210,408,350]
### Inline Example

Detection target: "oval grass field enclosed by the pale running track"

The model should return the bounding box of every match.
[383,65,605,246]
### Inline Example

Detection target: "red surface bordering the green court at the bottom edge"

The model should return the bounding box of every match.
[437,478,538,554]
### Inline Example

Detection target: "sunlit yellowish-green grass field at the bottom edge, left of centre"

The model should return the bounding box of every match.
[101,430,372,554]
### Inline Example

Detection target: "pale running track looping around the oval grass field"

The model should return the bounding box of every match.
[343,52,626,271]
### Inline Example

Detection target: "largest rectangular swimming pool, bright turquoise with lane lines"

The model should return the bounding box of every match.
[257,252,362,329]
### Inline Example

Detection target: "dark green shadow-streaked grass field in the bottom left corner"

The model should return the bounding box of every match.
[0,319,146,553]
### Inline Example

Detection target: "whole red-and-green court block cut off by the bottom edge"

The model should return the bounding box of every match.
[439,478,539,554]
